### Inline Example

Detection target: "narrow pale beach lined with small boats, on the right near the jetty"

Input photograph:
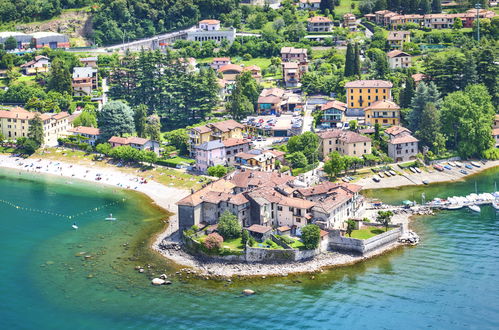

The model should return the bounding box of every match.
[355,160,499,189]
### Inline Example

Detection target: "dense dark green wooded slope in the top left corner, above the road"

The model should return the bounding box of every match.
[0,0,239,45]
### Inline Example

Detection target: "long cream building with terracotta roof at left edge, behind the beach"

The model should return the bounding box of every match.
[0,107,70,147]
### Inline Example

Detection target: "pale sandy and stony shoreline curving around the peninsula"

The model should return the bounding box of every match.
[0,155,499,278]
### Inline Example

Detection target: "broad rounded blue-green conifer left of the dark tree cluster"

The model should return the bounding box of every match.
[98,101,135,140]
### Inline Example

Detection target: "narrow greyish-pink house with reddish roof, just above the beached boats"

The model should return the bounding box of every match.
[385,126,419,162]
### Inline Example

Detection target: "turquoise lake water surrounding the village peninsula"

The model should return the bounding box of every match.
[0,168,499,329]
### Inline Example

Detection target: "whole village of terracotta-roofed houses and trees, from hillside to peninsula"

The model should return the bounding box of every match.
[0,0,499,258]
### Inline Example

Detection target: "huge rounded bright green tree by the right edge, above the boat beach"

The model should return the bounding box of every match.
[442,85,495,158]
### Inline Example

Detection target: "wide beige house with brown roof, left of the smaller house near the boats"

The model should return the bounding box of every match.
[318,129,372,159]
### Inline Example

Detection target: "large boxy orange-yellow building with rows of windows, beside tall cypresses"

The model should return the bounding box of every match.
[345,80,393,109]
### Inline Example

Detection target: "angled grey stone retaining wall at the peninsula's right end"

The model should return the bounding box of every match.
[329,224,402,254]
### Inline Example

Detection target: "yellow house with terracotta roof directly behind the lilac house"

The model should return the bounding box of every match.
[189,119,244,151]
